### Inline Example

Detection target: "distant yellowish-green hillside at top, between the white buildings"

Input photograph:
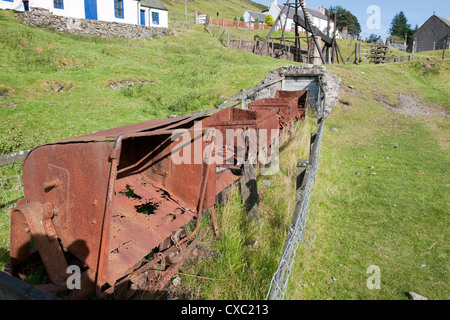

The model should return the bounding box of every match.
[162,0,267,20]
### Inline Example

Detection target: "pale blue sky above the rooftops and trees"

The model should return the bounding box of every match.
[253,0,450,39]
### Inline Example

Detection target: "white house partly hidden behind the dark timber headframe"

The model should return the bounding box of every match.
[264,0,334,34]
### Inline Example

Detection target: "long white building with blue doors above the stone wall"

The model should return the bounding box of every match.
[0,0,169,28]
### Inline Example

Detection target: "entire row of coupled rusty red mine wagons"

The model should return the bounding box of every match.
[7,92,307,299]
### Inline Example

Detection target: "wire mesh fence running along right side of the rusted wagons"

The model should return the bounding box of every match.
[266,118,324,300]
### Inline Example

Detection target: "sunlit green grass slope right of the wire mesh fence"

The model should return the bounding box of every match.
[294,61,450,300]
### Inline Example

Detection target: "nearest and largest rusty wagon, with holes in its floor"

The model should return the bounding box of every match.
[10,117,216,294]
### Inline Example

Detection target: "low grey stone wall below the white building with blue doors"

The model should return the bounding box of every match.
[16,11,172,39]
